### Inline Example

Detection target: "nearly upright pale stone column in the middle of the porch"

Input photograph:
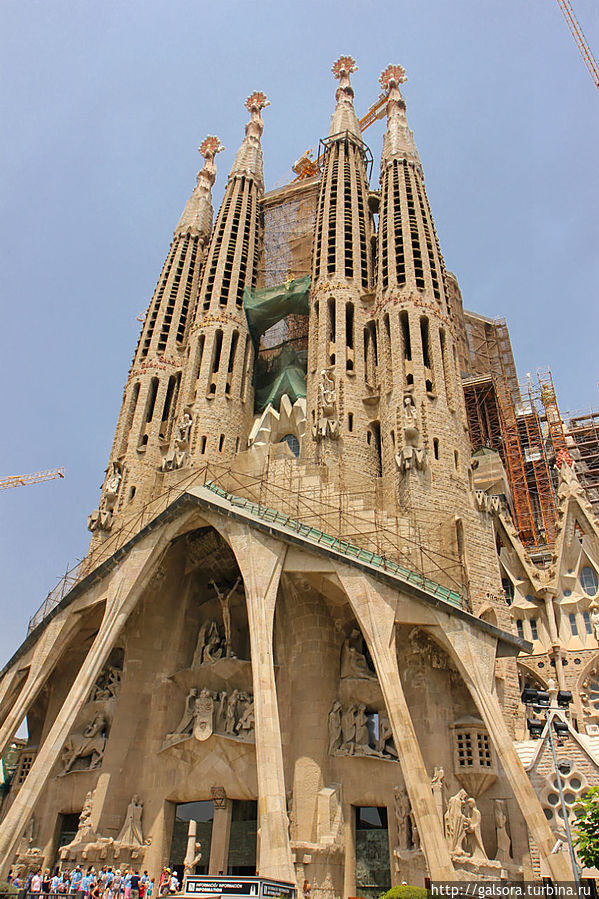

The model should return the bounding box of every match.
[227,523,295,883]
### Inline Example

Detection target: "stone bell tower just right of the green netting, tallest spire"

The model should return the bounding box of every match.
[307,56,379,477]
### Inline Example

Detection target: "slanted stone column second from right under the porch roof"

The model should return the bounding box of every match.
[336,565,456,880]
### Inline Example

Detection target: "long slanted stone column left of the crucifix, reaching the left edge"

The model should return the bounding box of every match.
[0,538,156,876]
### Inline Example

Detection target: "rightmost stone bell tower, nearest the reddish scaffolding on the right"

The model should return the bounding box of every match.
[374,65,507,622]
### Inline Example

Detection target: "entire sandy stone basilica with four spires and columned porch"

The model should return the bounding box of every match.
[0,57,599,899]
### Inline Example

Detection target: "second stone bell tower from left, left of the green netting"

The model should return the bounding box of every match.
[183,91,269,465]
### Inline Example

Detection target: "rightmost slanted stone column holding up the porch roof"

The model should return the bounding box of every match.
[431,612,573,881]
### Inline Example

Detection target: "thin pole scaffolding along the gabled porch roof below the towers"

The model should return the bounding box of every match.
[28,458,471,633]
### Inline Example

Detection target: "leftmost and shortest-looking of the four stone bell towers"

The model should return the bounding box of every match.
[88,137,223,537]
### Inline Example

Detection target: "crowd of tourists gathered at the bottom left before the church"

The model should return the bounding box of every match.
[8,865,180,899]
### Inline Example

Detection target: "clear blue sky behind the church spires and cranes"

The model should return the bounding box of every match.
[0,0,599,663]
